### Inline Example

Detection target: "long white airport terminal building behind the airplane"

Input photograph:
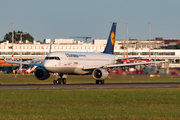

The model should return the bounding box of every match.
[0,39,180,63]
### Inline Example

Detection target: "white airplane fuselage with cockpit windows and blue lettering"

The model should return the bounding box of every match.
[43,51,117,74]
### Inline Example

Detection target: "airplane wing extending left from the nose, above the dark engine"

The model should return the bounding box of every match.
[4,60,43,67]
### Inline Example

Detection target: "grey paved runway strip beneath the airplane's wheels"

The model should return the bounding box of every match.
[0,82,180,90]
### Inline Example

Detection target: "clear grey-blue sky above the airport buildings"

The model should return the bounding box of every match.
[0,0,180,41]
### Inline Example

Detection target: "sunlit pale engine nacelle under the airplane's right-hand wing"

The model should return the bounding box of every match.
[92,68,109,80]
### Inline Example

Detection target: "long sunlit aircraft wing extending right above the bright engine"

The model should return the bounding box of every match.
[83,61,166,70]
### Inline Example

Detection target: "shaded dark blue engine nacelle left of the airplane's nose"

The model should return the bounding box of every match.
[34,67,50,80]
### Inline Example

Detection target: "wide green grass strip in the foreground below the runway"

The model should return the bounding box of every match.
[0,88,180,120]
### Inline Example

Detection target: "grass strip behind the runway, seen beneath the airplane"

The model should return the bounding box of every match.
[0,74,180,85]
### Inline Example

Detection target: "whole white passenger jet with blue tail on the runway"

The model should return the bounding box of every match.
[5,23,164,84]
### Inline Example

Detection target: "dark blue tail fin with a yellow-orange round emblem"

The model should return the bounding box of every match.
[103,22,116,54]
